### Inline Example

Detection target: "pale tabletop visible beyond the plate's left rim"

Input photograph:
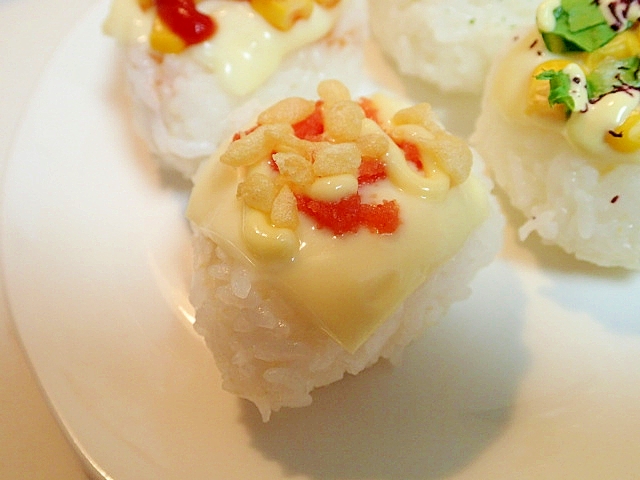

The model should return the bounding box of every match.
[0,0,96,480]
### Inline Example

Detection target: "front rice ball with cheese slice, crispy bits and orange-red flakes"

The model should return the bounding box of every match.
[187,80,503,421]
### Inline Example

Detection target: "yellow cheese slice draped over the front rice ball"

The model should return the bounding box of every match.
[187,86,488,352]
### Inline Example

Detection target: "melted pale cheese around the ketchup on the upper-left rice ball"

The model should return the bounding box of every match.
[103,0,343,96]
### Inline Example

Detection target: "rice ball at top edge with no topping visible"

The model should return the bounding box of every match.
[369,0,539,93]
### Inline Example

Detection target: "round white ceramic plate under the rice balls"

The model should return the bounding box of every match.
[2,2,640,480]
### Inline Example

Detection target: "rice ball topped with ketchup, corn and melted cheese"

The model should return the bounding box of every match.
[103,0,367,178]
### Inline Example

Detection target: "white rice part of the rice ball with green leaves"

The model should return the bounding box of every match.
[470,31,640,269]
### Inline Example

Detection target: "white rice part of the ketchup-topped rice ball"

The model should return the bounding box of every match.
[119,0,368,178]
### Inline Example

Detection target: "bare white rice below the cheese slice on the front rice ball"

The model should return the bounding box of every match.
[191,155,504,421]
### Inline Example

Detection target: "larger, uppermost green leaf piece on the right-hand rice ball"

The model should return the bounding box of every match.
[540,0,618,53]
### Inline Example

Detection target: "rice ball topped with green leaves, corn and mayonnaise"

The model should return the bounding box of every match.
[471,0,640,269]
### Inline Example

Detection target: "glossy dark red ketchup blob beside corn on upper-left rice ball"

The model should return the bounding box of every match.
[155,0,218,45]
